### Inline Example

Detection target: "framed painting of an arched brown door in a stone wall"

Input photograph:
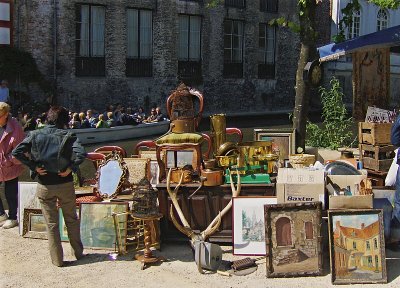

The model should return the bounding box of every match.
[264,202,322,278]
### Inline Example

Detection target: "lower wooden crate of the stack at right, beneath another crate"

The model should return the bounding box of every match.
[359,144,396,172]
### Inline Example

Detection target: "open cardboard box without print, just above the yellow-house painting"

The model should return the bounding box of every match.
[326,175,374,209]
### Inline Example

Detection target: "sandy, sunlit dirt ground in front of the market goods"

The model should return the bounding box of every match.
[0,224,400,288]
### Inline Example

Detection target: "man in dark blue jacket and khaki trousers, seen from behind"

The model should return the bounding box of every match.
[12,106,86,267]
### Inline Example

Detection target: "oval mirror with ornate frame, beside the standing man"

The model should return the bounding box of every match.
[98,157,125,198]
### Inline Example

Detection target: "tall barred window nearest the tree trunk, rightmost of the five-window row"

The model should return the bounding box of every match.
[258,23,276,79]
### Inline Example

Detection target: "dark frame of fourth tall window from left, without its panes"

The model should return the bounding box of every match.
[223,19,245,78]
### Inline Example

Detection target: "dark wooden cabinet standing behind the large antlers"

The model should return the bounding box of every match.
[157,183,275,242]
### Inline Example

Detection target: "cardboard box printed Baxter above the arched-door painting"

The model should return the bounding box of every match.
[276,168,325,208]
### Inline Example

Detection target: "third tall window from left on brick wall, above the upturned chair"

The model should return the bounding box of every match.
[178,15,202,80]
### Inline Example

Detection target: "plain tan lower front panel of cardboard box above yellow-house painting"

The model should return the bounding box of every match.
[329,194,374,209]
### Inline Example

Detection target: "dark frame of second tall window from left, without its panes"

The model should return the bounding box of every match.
[125,7,154,77]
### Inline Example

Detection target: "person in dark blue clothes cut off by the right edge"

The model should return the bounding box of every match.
[387,116,400,250]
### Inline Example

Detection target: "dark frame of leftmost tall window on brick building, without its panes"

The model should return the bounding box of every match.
[75,3,107,77]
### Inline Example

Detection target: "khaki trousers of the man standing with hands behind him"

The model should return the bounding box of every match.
[37,182,83,267]
